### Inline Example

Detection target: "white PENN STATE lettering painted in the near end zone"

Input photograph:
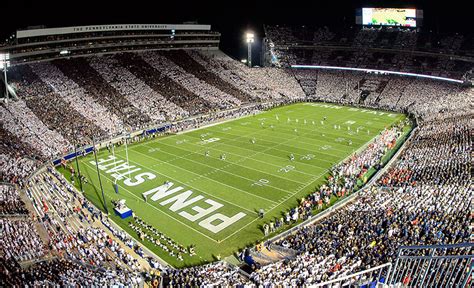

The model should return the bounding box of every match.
[89,155,247,233]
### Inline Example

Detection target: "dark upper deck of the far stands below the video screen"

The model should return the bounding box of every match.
[265,25,473,79]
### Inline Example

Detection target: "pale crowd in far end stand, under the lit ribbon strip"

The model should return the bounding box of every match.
[295,69,472,120]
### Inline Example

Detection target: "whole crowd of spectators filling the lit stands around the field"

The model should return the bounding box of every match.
[0,44,473,287]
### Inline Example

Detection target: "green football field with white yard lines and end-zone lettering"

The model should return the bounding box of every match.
[60,103,405,267]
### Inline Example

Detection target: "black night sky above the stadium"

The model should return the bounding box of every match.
[0,0,472,58]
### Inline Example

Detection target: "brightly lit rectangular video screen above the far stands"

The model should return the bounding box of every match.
[362,8,416,27]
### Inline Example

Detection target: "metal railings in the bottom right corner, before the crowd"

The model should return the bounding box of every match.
[313,243,474,288]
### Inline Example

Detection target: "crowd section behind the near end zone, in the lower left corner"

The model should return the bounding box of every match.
[0,168,149,287]
